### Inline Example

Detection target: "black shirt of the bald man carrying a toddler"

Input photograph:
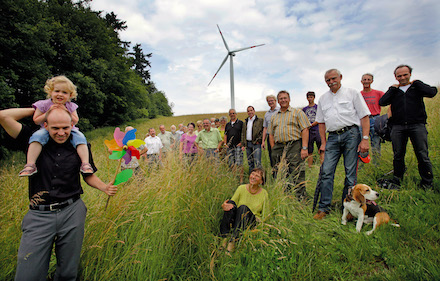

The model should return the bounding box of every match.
[16,125,97,205]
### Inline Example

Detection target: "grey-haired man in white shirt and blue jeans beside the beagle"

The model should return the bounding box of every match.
[313,69,371,220]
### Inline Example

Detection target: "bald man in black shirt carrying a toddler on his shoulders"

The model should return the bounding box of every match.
[0,107,117,280]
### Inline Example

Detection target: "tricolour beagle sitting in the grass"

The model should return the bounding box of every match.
[341,184,400,235]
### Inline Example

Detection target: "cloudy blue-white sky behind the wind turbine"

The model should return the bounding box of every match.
[87,0,440,115]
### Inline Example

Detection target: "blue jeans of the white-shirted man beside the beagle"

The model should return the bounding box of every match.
[319,127,361,212]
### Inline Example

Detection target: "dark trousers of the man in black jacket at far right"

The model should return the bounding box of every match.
[391,124,434,185]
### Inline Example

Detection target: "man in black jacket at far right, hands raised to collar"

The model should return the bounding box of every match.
[379,65,437,188]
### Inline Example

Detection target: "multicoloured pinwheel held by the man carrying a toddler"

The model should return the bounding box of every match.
[104,128,145,209]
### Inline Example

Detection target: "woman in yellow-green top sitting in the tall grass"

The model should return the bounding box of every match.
[220,168,269,252]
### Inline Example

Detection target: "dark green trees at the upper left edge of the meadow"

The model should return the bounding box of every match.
[0,0,172,158]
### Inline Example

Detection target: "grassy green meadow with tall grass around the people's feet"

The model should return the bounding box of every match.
[0,96,440,280]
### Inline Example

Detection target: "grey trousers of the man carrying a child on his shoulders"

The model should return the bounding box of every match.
[15,199,87,281]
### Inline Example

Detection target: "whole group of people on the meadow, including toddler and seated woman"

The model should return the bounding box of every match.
[0,65,437,280]
